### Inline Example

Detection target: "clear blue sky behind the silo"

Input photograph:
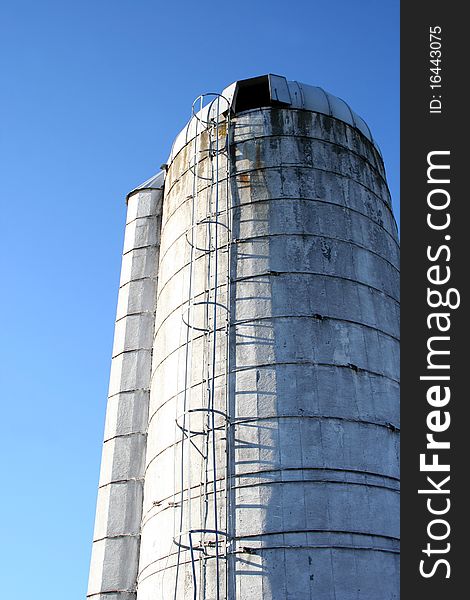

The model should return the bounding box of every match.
[0,0,399,600]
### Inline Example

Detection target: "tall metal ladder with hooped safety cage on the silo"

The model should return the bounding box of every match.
[174,94,232,600]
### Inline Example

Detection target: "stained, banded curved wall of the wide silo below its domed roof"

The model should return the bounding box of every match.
[136,109,399,600]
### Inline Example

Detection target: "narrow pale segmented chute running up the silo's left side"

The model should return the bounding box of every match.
[88,189,163,600]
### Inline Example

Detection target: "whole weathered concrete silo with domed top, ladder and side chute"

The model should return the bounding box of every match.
[89,75,399,600]
